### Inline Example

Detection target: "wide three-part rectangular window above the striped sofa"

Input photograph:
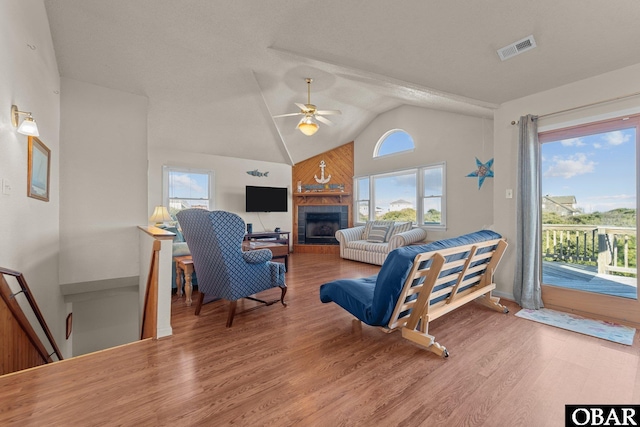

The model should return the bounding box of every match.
[354,163,446,229]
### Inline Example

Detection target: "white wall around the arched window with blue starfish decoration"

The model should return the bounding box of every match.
[354,106,493,240]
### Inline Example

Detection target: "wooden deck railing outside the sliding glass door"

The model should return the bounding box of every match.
[542,224,637,275]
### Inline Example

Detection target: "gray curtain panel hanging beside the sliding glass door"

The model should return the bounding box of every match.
[513,114,543,310]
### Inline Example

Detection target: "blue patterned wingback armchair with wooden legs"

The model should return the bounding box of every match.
[176,209,287,327]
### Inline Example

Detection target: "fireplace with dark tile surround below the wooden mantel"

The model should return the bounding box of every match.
[298,205,349,245]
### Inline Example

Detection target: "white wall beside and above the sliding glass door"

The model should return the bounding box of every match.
[493,64,640,298]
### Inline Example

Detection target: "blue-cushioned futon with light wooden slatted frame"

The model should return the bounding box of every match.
[320,230,509,357]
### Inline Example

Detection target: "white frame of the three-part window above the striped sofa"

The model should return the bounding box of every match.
[353,162,447,231]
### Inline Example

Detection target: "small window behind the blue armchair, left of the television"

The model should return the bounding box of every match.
[162,166,214,218]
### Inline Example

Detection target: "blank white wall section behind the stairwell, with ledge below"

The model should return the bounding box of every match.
[60,78,148,356]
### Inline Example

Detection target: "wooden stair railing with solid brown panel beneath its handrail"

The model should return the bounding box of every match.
[0,267,62,375]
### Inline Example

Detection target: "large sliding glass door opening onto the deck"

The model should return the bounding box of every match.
[540,117,640,324]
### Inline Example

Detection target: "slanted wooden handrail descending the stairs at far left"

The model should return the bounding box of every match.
[0,267,63,374]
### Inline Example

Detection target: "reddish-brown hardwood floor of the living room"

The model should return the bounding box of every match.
[0,254,640,426]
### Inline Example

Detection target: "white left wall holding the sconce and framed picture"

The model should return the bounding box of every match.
[0,0,71,357]
